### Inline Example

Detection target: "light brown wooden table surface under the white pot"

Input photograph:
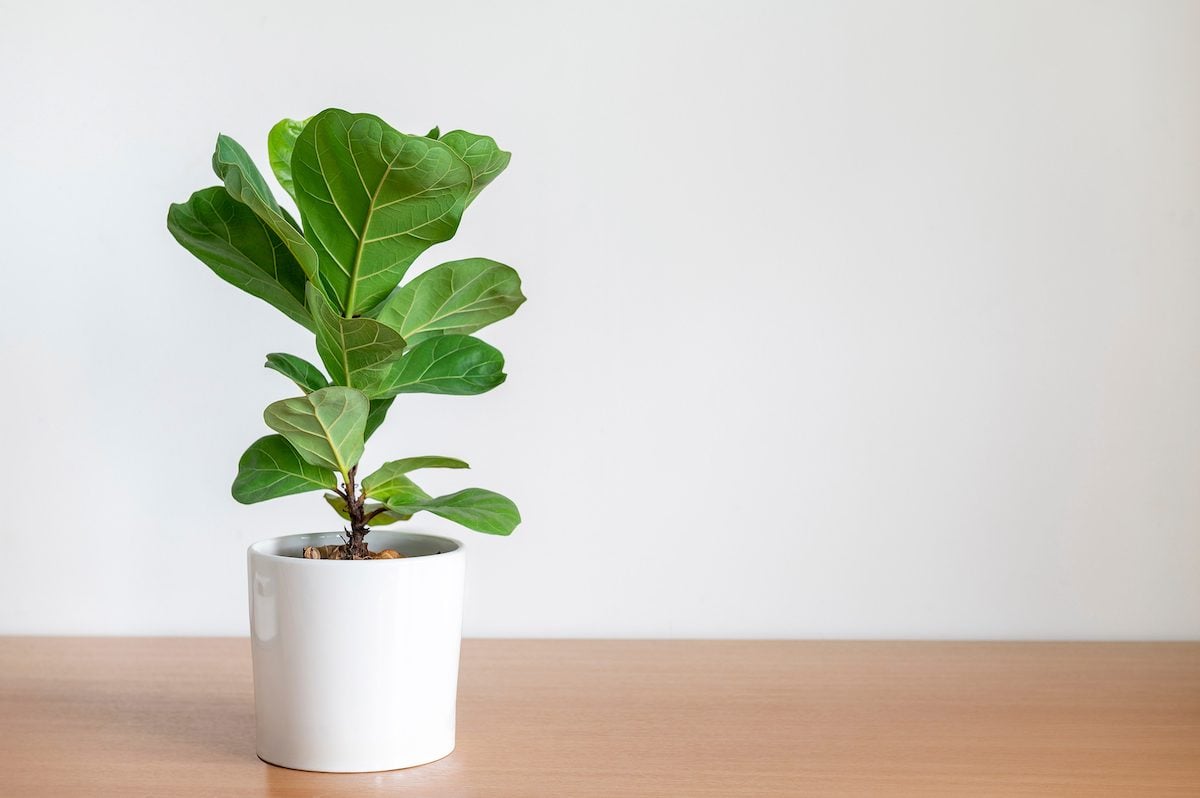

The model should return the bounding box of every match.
[0,637,1200,798]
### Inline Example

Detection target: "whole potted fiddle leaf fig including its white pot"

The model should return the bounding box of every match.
[167,108,524,772]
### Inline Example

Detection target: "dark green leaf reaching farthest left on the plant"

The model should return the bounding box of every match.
[167,186,313,330]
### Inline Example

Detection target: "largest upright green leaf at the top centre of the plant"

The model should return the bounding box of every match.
[292,108,475,318]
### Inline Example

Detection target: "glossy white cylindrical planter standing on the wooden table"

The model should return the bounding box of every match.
[247,530,466,773]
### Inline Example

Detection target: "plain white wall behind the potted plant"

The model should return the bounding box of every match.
[0,0,1200,638]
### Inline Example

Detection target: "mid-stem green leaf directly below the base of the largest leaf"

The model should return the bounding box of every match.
[308,283,404,398]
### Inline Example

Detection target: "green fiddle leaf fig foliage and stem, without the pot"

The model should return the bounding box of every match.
[167,108,524,559]
